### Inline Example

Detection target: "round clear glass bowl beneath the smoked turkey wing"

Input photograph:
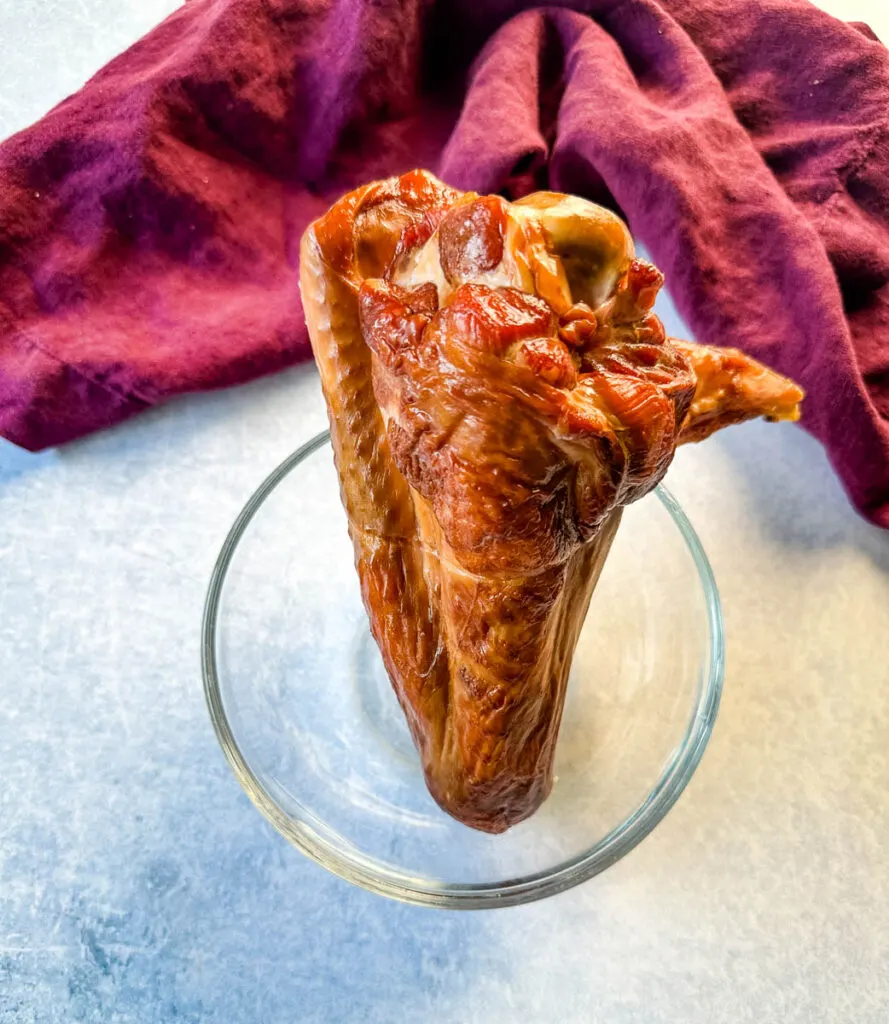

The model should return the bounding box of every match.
[202,434,724,908]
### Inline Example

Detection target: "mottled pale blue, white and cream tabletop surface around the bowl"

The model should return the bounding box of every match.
[0,0,889,1024]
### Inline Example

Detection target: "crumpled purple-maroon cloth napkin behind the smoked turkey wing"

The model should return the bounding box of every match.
[0,0,889,527]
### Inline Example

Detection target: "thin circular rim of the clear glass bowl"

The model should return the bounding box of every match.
[201,431,725,910]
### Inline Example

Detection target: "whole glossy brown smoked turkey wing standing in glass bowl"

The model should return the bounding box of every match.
[300,171,802,833]
